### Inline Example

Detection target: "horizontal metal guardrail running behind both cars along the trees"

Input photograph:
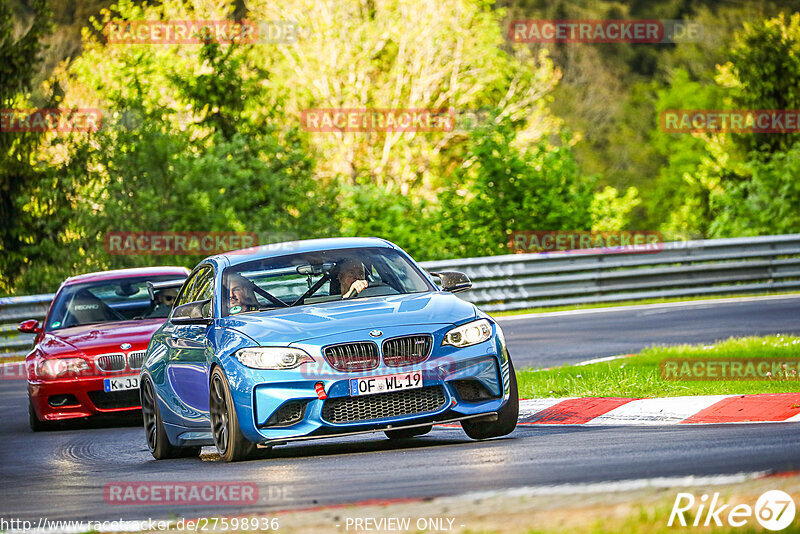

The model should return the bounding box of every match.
[0,234,800,358]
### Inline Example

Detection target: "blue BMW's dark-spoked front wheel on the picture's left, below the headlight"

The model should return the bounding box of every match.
[208,367,261,462]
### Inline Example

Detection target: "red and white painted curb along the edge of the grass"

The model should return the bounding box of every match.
[519,393,800,425]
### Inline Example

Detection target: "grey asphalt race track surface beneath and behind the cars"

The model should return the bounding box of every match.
[0,297,800,528]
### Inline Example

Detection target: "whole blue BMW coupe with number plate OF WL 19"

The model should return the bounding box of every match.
[140,238,519,461]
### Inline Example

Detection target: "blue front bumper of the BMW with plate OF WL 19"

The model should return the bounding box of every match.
[219,324,509,446]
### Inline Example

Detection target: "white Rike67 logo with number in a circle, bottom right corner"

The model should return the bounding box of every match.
[667,490,796,531]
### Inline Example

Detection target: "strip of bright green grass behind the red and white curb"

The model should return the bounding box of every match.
[517,335,800,398]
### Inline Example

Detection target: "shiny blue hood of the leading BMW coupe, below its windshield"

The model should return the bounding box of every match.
[220,292,476,345]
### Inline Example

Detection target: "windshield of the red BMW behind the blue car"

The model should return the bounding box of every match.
[45,274,185,331]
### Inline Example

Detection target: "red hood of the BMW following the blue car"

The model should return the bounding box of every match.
[39,318,166,357]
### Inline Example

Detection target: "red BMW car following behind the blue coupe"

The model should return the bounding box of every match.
[19,267,189,432]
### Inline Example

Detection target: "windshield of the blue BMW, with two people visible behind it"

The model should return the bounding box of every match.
[222,247,435,316]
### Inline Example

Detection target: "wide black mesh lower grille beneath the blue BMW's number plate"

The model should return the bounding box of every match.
[322,386,447,424]
